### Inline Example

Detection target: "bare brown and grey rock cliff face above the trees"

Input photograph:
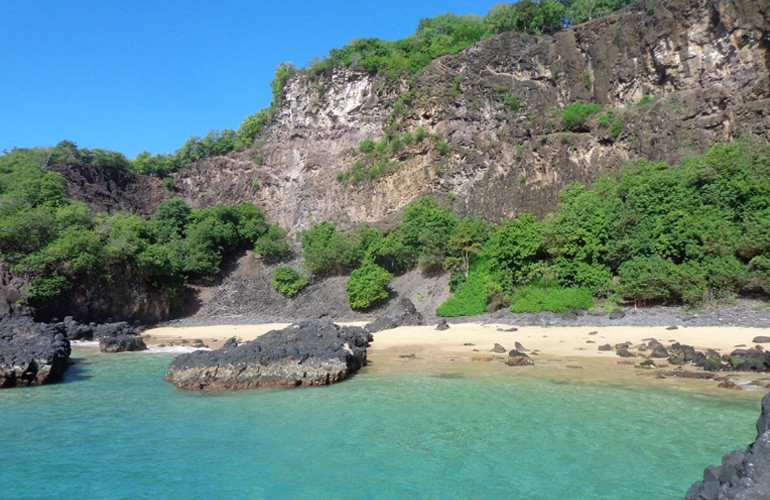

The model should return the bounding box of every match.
[165,0,770,230]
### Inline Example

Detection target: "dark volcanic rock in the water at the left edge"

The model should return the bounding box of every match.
[0,316,71,388]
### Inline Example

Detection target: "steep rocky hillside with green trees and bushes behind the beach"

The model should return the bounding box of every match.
[0,0,770,322]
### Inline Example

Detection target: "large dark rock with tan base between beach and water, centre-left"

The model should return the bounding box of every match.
[166,319,372,390]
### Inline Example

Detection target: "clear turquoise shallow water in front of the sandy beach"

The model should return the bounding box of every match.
[0,351,759,499]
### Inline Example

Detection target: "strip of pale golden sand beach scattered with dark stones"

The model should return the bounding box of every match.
[142,322,770,400]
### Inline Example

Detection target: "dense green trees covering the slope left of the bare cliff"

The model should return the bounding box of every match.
[0,146,286,301]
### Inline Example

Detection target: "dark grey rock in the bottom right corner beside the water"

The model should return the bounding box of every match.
[685,393,770,500]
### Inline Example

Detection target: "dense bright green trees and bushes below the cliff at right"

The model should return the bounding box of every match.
[437,141,770,316]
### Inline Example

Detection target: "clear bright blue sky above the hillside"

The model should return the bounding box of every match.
[0,0,500,158]
